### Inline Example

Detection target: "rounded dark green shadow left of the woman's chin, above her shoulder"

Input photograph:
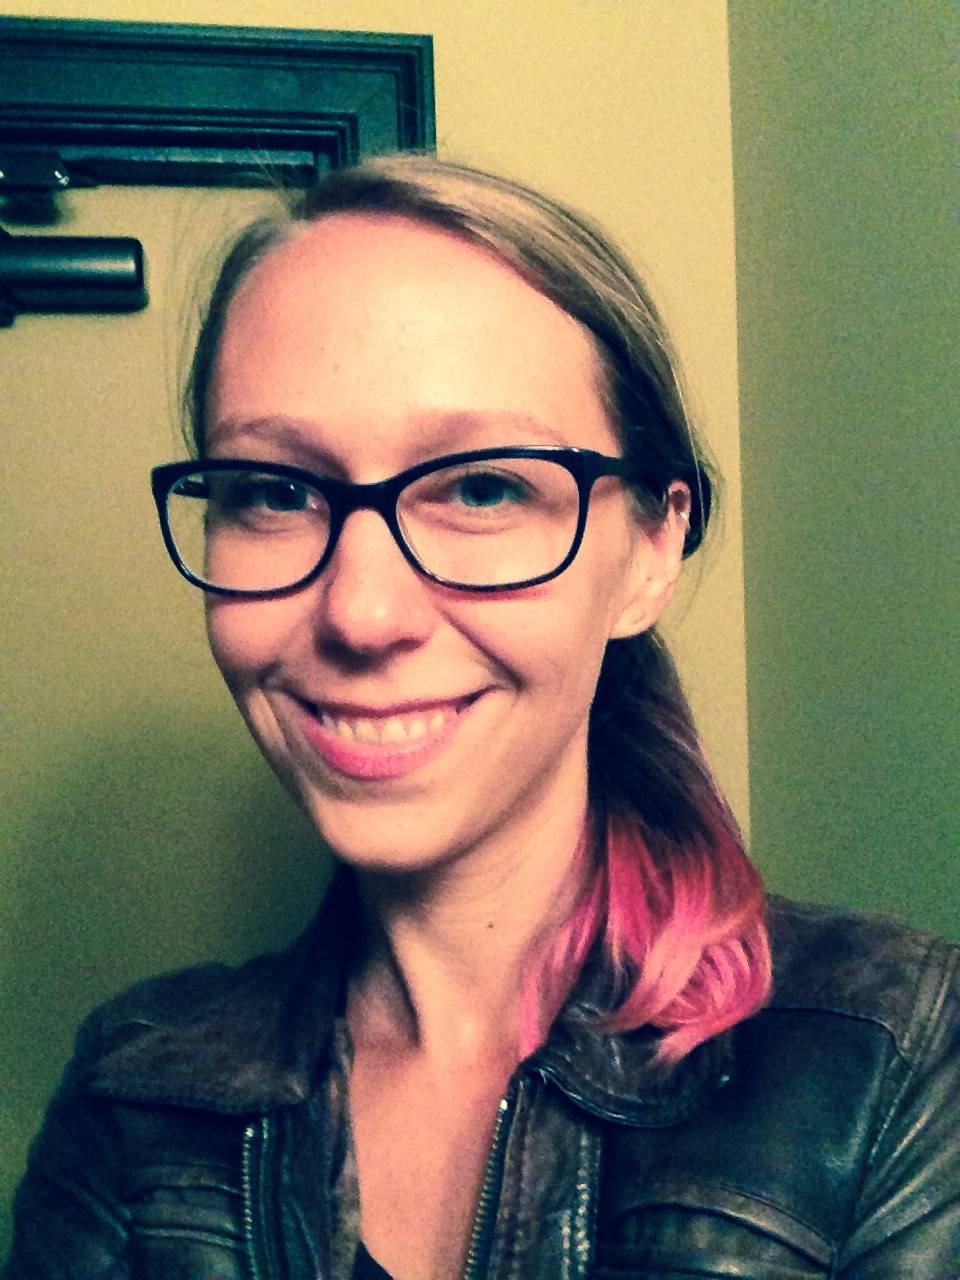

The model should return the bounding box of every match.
[0,708,330,1258]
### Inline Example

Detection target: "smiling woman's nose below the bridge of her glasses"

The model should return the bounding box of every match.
[316,509,436,658]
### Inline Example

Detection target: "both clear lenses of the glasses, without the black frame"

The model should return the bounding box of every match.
[168,458,580,591]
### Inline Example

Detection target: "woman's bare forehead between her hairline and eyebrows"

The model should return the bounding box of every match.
[210,214,613,463]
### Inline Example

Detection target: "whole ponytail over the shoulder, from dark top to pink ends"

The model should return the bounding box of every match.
[521,634,771,1068]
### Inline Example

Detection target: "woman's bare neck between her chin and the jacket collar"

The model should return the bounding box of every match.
[348,810,585,1068]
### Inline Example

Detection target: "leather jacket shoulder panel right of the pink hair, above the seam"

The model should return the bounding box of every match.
[765,896,960,1061]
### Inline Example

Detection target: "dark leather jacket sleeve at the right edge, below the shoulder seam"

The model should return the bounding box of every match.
[836,942,960,1280]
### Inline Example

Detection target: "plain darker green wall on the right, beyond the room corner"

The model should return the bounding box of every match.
[730,0,960,936]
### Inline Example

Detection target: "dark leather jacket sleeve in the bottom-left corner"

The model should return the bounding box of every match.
[3,1024,129,1280]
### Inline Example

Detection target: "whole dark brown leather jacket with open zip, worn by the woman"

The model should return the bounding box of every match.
[5,890,960,1280]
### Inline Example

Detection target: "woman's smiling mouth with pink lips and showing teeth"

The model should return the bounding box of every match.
[301,692,481,780]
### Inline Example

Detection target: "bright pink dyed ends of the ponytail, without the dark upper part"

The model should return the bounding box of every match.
[521,803,771,1066]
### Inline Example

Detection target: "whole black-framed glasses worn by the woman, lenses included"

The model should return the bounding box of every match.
[151,447,660,598]
